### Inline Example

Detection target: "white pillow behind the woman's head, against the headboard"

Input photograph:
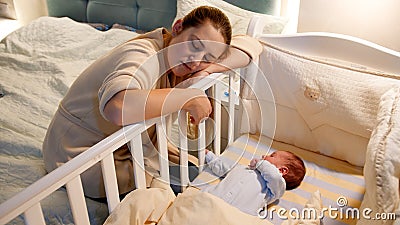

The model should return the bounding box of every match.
[174,0,288,35]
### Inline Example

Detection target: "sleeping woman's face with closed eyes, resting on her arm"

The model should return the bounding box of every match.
[167,22,227,77]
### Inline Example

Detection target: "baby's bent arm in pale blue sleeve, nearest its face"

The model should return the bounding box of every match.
[256,160,286,204]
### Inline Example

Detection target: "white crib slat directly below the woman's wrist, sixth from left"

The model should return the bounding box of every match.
[178,111,189,191]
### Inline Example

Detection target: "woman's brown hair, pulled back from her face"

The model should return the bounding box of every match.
[182,6,232,45]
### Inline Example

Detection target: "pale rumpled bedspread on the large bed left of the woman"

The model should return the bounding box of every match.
[0,17,137,224]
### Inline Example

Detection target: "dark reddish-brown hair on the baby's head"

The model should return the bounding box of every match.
[283,151,306,190]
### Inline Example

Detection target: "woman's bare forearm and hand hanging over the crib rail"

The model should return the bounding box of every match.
[104,88,212,126]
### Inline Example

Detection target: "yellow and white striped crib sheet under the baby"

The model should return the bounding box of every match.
[192,135,365,225]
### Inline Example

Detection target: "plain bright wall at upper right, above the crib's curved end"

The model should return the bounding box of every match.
[298,0,400,52]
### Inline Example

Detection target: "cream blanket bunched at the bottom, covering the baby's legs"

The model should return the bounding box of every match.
[104,185,271,225]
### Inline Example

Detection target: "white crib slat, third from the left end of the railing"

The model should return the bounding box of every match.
[101,154,120,213]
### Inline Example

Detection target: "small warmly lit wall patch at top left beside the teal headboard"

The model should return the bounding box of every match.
[14,0,47,25]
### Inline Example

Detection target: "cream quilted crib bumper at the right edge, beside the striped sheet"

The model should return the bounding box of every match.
[361,88,400,224]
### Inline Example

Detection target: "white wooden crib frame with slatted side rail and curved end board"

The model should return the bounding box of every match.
[0,15,400,224]
